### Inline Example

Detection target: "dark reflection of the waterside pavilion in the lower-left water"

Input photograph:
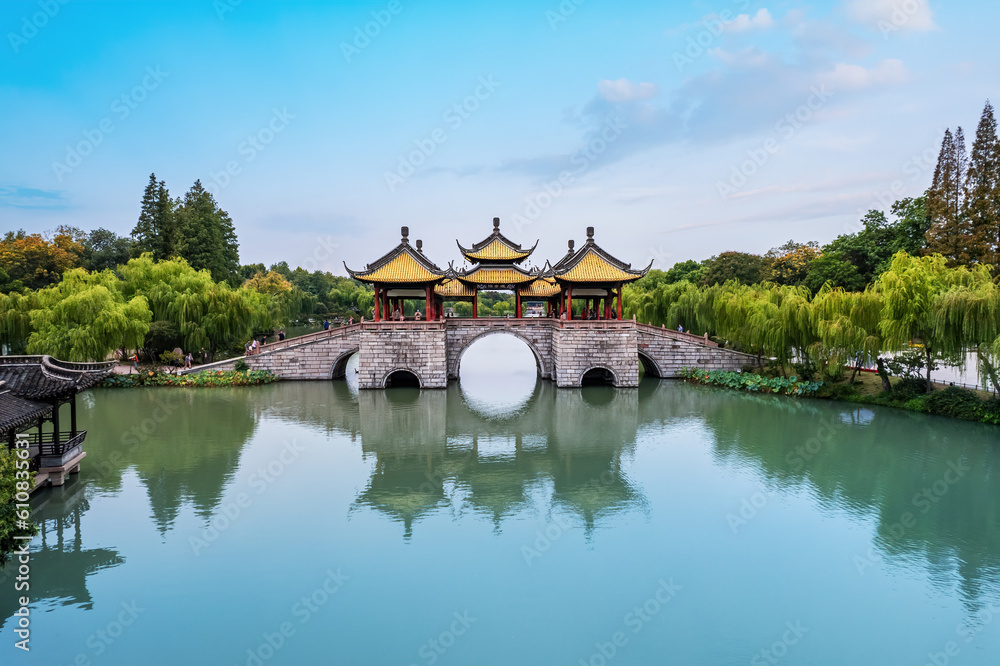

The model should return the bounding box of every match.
[0,480,125,629]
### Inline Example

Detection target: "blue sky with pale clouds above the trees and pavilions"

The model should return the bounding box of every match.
[0,0,1000,274]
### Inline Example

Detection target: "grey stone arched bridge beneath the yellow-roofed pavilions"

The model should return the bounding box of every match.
[191,318,753,389]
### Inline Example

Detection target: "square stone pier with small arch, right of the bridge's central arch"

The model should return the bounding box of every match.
[552,321,639,387]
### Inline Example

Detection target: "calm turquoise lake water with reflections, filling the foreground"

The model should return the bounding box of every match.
[0,338,1000,666]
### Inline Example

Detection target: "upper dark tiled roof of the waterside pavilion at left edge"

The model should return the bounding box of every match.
[0,356,115,400]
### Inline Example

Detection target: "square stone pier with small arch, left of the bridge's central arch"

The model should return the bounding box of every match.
[358,321,448,389]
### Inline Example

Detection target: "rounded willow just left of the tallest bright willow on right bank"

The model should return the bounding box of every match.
[812,286,882,384]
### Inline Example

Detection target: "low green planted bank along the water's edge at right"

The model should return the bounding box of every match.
[682,368,1000,425]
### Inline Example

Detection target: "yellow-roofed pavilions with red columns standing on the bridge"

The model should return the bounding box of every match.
[344,217,652,321]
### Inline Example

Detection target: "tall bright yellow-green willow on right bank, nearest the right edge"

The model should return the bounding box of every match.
[874,252,989,393]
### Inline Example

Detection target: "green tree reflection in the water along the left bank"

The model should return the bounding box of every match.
[84,387,260,533]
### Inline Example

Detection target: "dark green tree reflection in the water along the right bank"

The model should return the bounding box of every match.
[688,386,1000,600]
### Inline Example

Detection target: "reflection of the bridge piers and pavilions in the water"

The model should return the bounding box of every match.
[355,382,645,537]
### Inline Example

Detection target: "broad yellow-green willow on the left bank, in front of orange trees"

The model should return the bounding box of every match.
[28,268,152,361]
